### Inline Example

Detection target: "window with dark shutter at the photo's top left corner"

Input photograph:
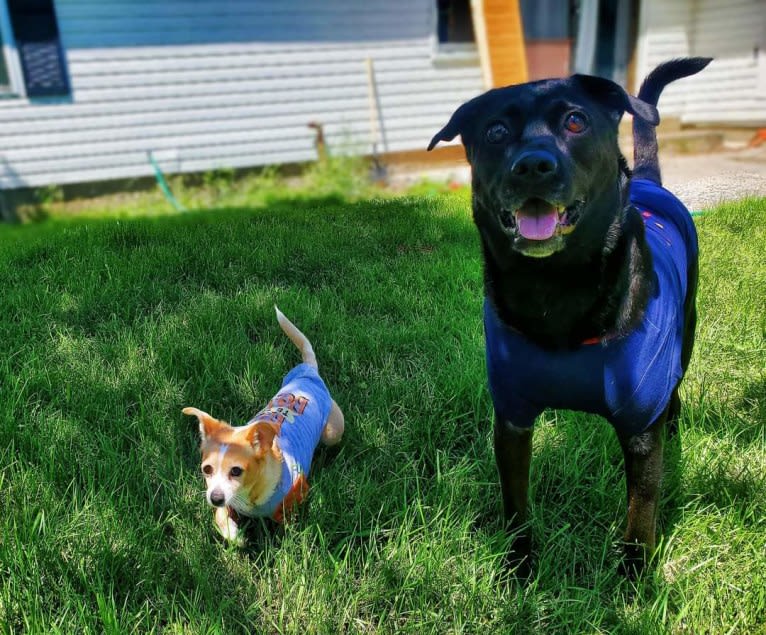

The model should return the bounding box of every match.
[0,0,70,98]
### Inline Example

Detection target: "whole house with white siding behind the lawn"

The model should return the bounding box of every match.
[0,0,766,211]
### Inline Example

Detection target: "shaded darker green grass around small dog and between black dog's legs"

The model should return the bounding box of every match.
[2,191,764,630]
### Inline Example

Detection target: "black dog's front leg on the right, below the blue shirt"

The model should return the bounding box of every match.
[619,412,667,574]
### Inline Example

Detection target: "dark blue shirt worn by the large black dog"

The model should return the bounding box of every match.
[484,180,697,435]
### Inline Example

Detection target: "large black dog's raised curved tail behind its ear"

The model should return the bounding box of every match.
[633,57,713,185]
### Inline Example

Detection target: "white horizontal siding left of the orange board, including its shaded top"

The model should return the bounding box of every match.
[0,0,482,188]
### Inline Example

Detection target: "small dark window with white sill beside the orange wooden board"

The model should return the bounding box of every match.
[434,0,478,64]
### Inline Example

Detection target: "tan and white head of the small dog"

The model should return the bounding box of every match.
[183,408,282,514]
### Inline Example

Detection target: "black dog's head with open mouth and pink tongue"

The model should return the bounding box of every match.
[428,75,659,259]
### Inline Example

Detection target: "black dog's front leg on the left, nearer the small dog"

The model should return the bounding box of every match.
[495,416,532,568]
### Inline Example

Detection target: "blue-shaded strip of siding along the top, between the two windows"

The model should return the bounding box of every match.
[58,0,433,48]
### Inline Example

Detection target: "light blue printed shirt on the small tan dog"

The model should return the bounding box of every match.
[248,364,332,522]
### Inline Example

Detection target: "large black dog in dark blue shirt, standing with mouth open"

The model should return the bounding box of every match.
[428,58,710,569]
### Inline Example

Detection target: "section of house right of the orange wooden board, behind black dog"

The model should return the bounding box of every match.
[520,0,766,127]
